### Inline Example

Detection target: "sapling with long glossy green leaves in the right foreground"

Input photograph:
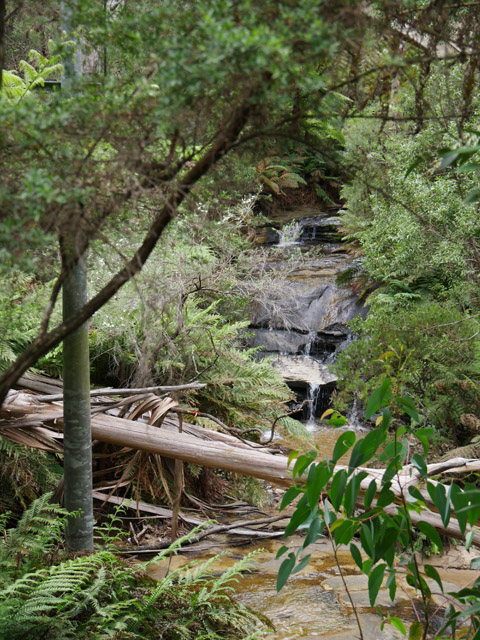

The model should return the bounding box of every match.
[277,378,480,640]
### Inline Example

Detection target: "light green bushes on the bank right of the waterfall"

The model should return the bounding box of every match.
[338,63,479,444]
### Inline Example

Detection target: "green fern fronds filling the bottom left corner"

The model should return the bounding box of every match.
[0,493,268,640]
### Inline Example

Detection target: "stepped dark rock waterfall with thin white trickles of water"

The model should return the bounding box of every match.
[251,204,362,429]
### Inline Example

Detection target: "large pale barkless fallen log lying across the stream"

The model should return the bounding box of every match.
[0,392,480,545]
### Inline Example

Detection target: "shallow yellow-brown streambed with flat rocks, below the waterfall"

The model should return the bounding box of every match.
[145,428,477,640]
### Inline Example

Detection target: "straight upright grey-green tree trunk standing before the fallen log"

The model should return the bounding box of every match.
[61,2,93,551]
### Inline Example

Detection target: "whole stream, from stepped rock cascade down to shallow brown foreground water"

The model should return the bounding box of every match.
[150,207,472,640]
